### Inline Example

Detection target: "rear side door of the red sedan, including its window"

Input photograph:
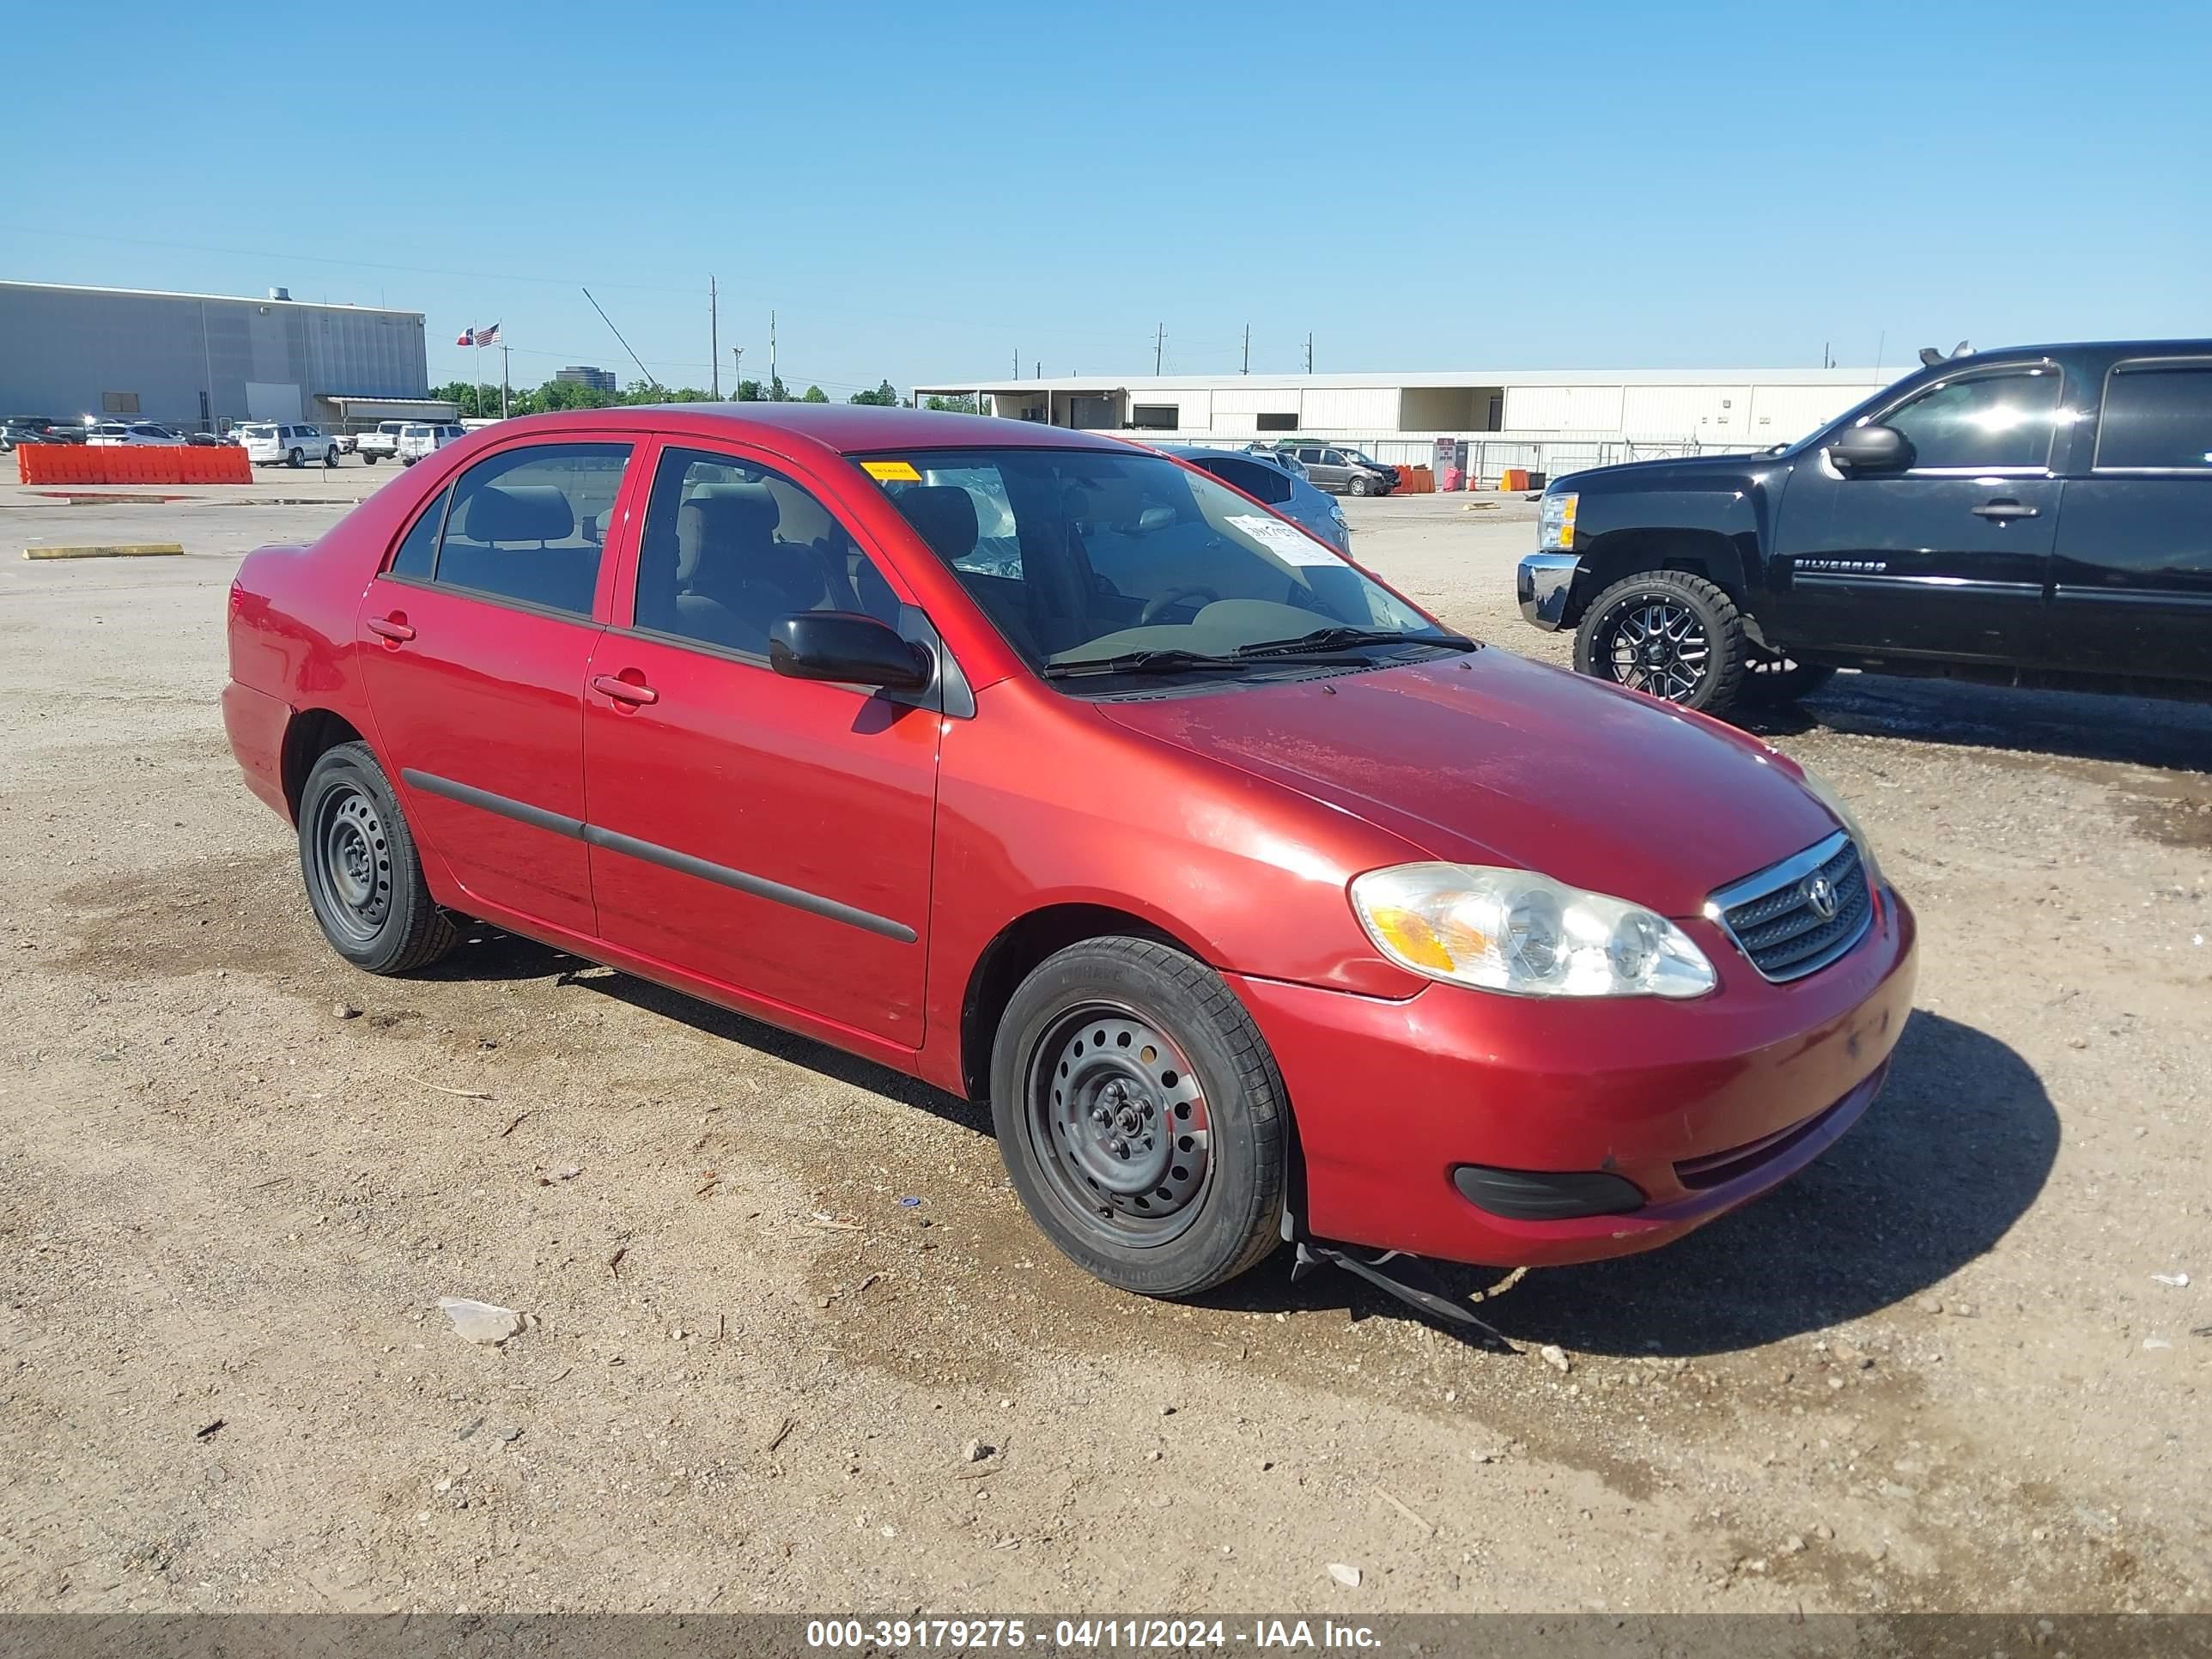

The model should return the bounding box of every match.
[361,434,635,936]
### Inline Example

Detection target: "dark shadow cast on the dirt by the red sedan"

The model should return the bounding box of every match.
[422,925,2059,1356]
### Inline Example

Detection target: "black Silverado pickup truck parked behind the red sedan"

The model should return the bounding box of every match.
[1517,341,2212,714]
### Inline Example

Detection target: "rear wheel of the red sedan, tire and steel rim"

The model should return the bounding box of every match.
[299,744,458,973]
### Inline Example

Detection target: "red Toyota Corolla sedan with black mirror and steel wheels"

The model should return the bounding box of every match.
[223,404,1913,1297]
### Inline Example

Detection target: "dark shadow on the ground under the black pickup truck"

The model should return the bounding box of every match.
[1739,675,2212,772]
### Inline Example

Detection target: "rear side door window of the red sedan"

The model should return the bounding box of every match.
[427,442,630,617]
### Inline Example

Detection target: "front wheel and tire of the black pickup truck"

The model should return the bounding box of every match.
[1575,571,1747,714]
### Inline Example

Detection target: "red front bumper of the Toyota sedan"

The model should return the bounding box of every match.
[1230,890,1913,1267]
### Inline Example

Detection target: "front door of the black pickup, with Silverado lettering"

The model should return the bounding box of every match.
[1760,362,2069,664]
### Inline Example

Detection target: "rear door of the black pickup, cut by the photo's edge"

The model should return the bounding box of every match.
[2051,356,2212,681]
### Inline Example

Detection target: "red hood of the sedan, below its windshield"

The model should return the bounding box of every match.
[1097,648,1838,915]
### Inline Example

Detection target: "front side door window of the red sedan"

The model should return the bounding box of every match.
[633,449,898,659]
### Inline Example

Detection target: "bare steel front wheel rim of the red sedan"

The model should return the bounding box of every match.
[1024,1002,1214,1248]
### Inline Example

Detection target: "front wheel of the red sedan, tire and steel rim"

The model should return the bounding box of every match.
[991,938,1290,1297]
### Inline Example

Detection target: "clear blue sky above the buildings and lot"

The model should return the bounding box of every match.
[0,0,2212,396]
